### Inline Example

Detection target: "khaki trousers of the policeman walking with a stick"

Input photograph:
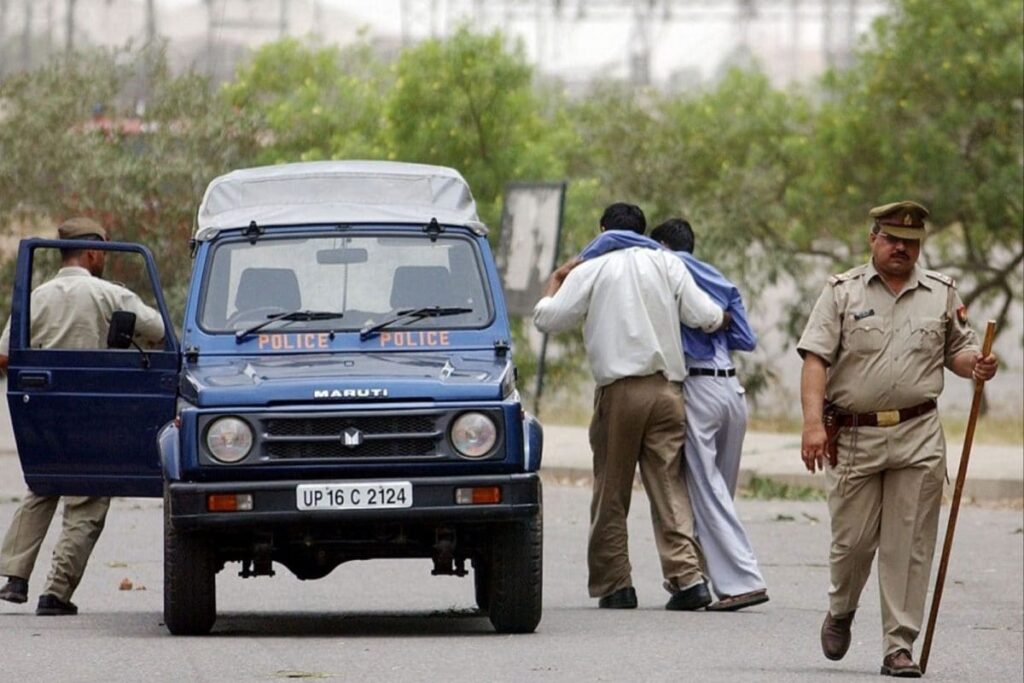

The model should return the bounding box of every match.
[826,411,946,655]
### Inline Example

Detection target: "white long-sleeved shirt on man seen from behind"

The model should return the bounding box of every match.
[534,247,722,386]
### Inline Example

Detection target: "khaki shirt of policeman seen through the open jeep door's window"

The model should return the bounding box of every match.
[0,266,164,355]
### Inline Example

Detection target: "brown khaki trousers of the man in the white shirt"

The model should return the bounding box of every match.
[587,374,703,598]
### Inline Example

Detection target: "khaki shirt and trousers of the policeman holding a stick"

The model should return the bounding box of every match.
[797,263,979,655]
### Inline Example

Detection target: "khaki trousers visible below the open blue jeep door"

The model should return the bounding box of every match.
[0,492,111,602]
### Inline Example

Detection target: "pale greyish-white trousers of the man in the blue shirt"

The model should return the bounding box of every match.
[683,375,765,598]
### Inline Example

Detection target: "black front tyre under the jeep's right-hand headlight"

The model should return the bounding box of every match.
[487,493,544,633]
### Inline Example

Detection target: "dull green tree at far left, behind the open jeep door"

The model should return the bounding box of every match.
[0,44,257,321]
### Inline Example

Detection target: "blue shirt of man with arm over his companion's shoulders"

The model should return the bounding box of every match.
[580,230,758,360]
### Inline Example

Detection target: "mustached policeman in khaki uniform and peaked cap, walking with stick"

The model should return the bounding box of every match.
[797,202,996,678]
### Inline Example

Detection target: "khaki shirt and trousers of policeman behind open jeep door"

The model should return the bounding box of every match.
[0,267,164,602]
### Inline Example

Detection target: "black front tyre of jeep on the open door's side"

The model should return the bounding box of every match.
[164,487,217,636]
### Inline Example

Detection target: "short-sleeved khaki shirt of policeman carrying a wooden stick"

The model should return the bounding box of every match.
[797,263,980,413]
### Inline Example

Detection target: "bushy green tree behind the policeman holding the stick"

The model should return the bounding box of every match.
[815,0,1024,328]
